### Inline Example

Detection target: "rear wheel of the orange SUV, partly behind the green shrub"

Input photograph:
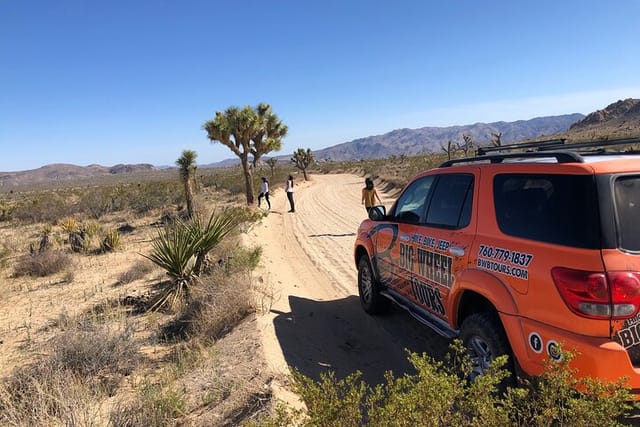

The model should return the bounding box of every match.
[460,312,516,386]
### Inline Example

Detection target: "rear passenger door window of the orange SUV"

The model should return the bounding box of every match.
[427,174,473,229]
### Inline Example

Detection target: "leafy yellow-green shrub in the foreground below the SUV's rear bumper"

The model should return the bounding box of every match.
[265,340,631,427]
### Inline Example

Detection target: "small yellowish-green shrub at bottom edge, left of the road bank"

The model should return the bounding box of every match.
[109,382,186,427]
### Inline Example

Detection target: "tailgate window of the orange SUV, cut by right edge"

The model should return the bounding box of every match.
[613,176,640,252]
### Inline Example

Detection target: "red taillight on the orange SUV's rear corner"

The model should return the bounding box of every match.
[551,267,640,319]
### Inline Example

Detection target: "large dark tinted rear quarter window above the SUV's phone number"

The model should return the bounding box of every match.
[493,174,600,249]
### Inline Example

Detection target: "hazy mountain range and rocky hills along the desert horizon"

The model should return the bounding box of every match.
[5,98,640,191]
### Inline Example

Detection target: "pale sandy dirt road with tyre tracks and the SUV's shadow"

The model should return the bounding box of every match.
[248,174,448,396]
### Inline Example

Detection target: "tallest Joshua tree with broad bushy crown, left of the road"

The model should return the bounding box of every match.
[202,103,288,205]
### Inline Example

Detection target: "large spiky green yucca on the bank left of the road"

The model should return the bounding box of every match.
[143,211,240,311]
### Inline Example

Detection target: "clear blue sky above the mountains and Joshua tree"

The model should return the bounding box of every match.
[0,0,640,172]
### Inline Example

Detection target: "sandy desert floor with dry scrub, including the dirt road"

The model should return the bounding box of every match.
[0,100,639,426]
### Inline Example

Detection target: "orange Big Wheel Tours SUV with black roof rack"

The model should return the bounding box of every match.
[354,139,640,394]
